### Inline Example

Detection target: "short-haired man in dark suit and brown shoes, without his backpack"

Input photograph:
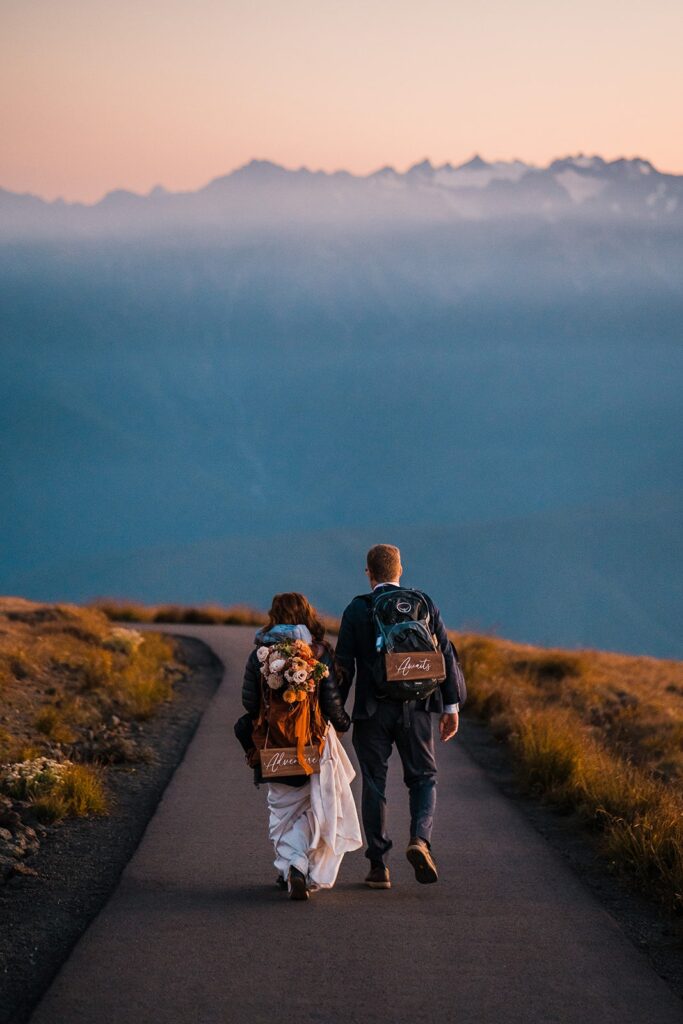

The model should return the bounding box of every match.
[336,544,465,889]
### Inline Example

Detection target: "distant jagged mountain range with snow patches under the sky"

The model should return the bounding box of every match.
[0,154,683,237]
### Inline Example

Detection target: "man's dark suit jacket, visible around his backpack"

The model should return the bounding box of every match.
[335,584,467,721]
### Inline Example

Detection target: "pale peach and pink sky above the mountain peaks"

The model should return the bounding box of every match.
[0,0,683,202]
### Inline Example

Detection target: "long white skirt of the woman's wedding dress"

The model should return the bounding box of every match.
[267,727,362,889]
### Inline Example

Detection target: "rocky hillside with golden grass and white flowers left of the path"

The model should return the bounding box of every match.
[0,598,183,879]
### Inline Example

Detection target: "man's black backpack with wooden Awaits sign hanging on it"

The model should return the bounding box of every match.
[370,587,445,700]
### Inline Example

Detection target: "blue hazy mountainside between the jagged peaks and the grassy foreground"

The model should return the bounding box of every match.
[0,159,683,657]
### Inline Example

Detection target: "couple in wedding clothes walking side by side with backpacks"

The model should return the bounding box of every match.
[237,544,466,899]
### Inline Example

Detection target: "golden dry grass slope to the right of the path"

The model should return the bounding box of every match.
[453,634,683,910]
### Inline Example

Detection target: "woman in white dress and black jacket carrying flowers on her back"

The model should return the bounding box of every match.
[242,593,362,900]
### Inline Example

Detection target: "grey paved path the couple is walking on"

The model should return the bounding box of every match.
[32,627,683,1024]
